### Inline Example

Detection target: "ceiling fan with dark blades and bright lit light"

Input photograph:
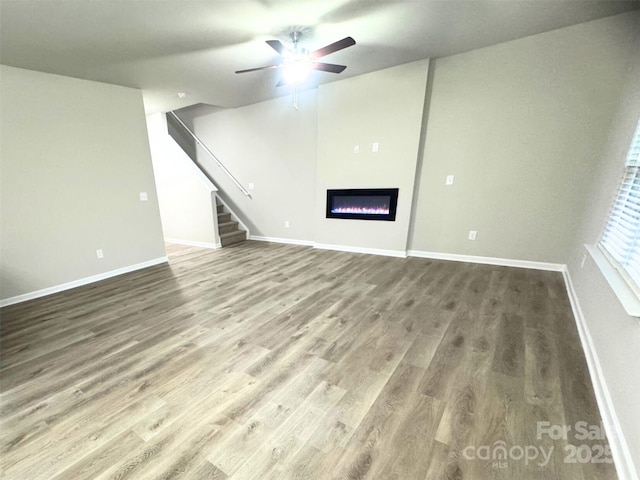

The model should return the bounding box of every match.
[236,31,356,87]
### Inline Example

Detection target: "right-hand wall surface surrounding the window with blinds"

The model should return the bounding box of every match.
[567,14,640,472]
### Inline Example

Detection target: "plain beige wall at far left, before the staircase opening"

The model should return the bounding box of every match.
[0,66,165,300]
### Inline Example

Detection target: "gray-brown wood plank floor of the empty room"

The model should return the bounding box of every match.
[0,242,617,480]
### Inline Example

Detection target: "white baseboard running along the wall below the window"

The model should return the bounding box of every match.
[562,268,638,480]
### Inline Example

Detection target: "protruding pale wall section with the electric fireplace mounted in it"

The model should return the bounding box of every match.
[314,60,428,255]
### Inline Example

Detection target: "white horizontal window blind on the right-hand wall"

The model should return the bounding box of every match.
[600,121,640,294]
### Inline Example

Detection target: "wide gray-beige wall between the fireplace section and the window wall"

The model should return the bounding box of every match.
[411,15,632,263]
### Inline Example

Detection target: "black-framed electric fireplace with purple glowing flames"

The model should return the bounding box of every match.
[327,188,398,222]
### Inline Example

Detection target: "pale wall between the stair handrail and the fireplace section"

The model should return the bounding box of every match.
[181,91,317,242]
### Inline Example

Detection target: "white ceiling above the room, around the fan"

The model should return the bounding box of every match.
[0,0,640,113]
